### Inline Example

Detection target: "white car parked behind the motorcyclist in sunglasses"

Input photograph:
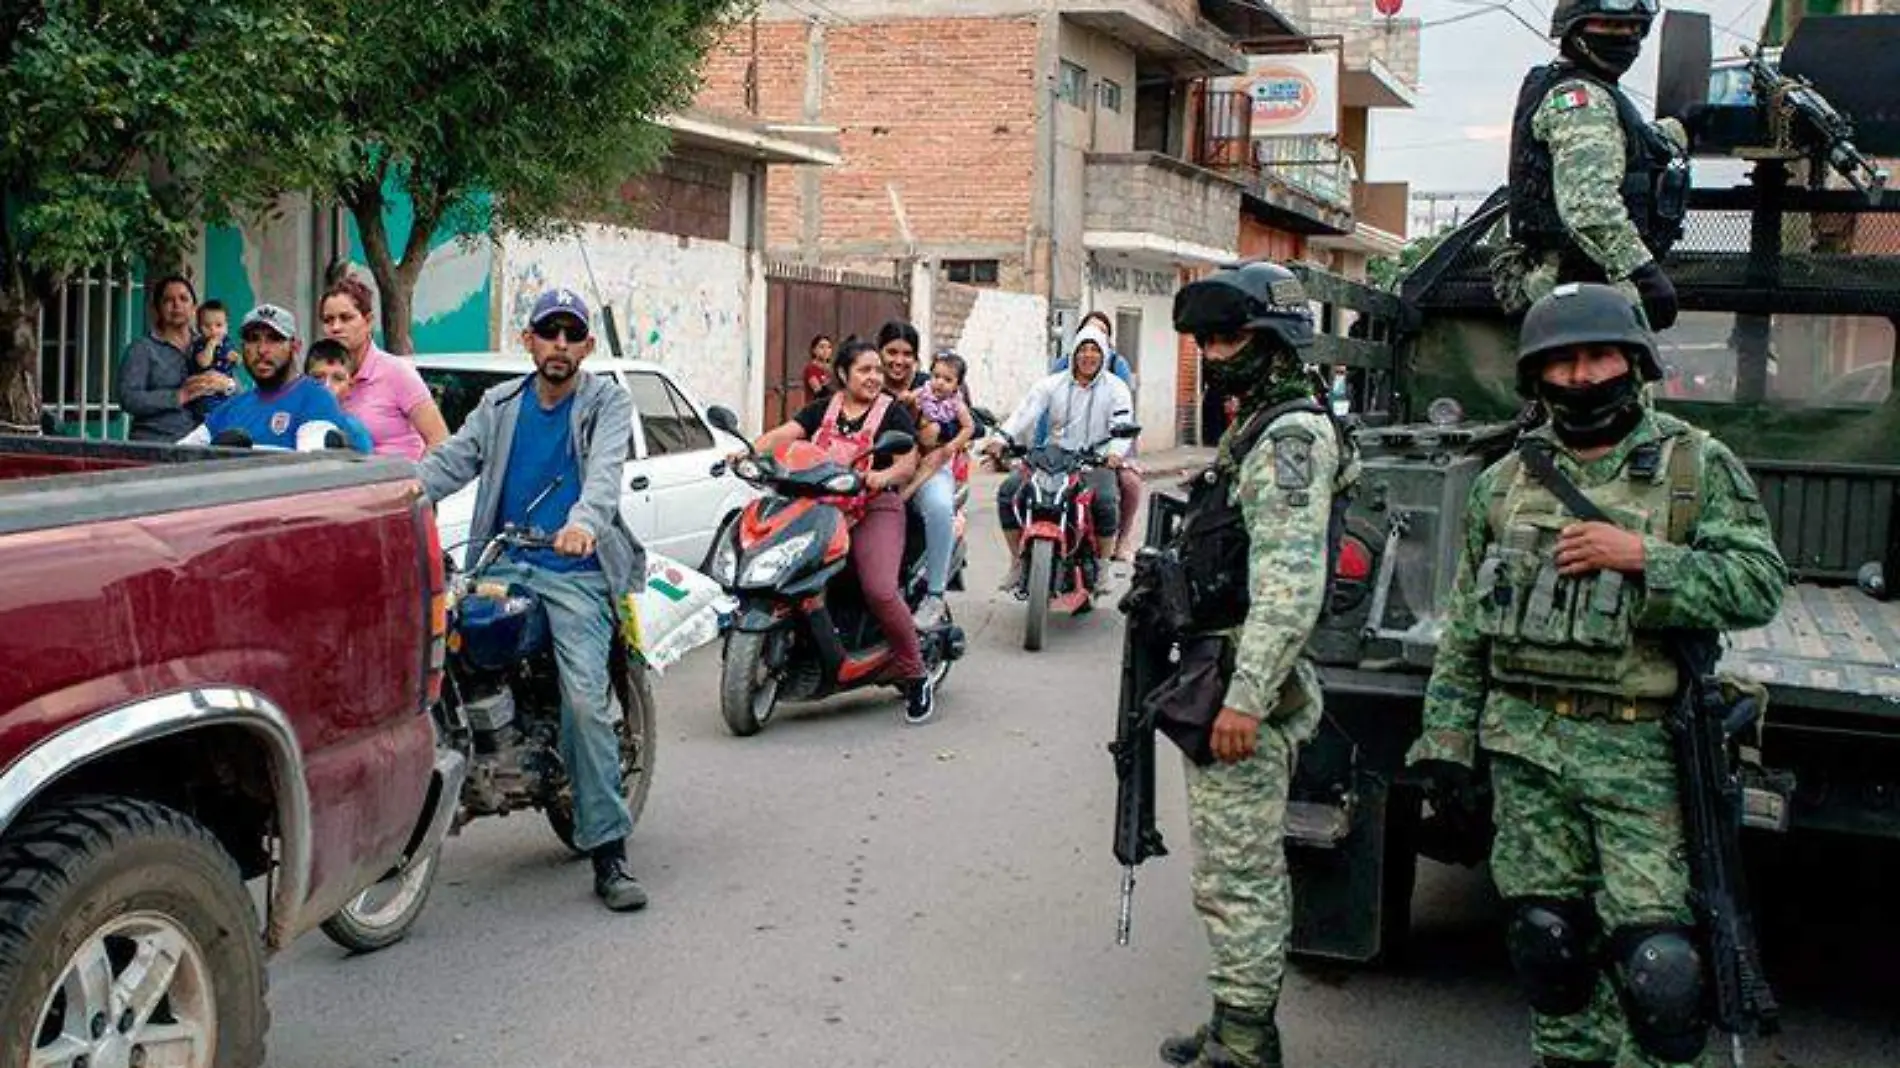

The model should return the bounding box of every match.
[416,352,758,570]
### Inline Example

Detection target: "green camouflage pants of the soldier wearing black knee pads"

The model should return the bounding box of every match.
[1492,720,1691,1068]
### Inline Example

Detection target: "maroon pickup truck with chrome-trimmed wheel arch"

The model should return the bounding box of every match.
[0,437,462,1066]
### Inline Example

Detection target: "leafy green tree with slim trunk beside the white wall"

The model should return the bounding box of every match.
[325,0,749,352]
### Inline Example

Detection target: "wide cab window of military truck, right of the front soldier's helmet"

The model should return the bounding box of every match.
[1659,312,1894,409]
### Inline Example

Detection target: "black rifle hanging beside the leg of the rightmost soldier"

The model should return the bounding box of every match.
[1668,631,1780,1068]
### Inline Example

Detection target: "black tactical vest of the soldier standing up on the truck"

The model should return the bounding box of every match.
[1511,63,1689,267]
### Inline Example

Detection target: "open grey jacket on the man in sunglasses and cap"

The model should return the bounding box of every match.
[416,371,646,592]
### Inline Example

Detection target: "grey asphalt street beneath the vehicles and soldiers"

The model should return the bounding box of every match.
[270,471,1900,1068]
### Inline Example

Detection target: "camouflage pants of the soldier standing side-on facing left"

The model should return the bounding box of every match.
[1188,724,1294,1011]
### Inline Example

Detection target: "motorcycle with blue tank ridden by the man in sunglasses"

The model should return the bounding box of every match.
[323,528,659,952]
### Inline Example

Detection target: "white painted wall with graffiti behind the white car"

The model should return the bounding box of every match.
[502,226,764,426]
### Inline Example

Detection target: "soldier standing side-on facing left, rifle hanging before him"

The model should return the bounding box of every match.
[1161,262,1357,1068]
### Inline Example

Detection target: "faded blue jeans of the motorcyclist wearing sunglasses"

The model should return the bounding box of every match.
[488,561,633,851]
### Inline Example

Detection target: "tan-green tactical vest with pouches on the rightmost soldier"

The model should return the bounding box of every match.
[1474,414,1706,697]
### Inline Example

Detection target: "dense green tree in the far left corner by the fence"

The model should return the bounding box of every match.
[0,0,338,429]
